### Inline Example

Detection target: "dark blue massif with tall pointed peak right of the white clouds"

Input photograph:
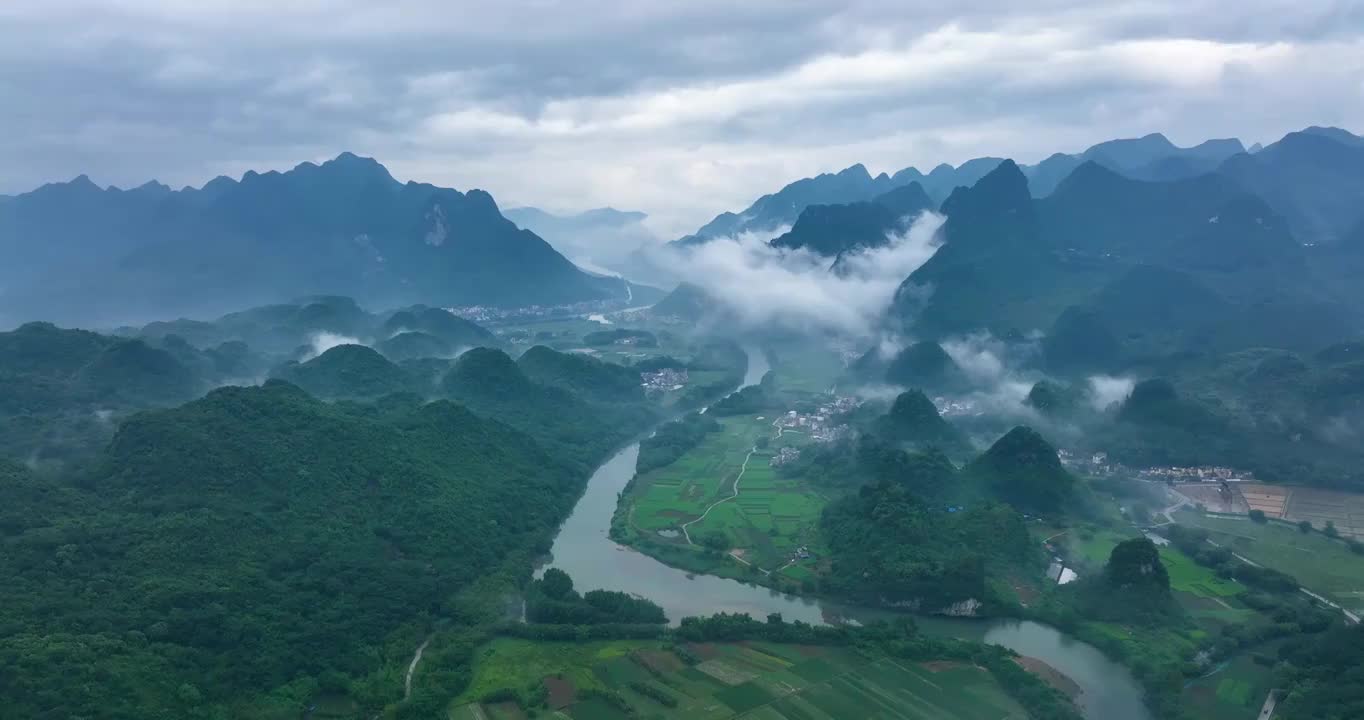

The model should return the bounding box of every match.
[896,147,1364,357]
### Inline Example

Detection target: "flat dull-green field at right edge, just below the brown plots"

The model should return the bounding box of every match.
[1176,510,1364,612]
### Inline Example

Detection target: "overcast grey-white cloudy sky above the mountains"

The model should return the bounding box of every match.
[0,0,1364,236]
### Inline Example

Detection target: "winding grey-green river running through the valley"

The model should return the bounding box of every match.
[534,348,1151,720]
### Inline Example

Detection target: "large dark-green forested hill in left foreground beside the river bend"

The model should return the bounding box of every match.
[0,380,585,720]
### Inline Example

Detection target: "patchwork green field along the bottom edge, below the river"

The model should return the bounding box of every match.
[449,638,1026,720]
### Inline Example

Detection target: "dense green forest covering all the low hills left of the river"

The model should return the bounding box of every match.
[0,313,679,719]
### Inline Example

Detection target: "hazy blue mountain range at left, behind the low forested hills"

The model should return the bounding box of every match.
[0,153,630,330]
